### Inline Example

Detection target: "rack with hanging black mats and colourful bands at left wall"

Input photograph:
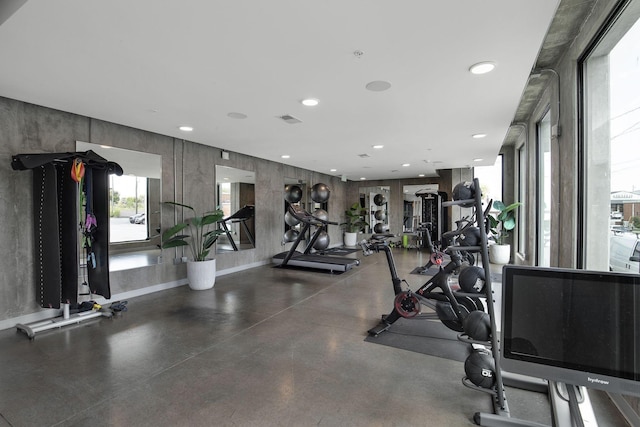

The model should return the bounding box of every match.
[11,151,123,338]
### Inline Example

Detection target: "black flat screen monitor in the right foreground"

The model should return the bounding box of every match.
[500,265,640,396]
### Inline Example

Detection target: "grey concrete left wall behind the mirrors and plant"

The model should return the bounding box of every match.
[0,97,348,329]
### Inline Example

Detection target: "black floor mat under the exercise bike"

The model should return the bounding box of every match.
[365,319,471,362]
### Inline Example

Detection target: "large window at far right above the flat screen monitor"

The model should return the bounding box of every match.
[578,0,640,273]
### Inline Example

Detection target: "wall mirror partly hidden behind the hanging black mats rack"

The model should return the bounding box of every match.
[76,141,162,271]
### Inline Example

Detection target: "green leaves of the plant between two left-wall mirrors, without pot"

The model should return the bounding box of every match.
[162,202,224,261]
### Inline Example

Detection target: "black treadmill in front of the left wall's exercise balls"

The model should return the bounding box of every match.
[272,204,360,272]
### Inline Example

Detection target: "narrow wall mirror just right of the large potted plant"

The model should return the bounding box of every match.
[216,165,256,253]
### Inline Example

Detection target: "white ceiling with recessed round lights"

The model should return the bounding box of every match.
[0,0,559,180]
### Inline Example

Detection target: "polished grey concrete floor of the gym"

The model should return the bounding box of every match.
[0,249,625,427]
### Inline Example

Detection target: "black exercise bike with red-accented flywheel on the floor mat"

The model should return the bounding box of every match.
[360,211,485,336]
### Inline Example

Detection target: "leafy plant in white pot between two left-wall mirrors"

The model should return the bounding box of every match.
[162,202,224,290]
